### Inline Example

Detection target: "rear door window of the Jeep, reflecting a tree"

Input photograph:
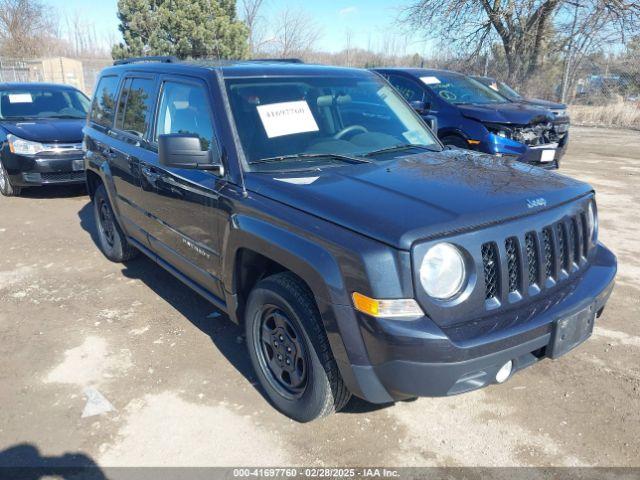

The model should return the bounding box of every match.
[116,78,155,138]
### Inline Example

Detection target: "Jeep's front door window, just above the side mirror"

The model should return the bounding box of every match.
[154,81,213,150]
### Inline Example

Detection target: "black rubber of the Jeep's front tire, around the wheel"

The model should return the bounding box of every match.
[245,285,331,422]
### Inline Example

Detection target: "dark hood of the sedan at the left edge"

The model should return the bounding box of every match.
[0,119,86,143]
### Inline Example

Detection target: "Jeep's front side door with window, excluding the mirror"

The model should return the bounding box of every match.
[141,76,227,298]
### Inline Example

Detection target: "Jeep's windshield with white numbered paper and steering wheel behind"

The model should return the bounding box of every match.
[226,75,441,170]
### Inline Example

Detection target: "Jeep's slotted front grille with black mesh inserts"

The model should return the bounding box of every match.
[481,208,588,308]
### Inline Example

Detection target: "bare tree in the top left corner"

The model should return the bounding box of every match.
[0,0,59,58]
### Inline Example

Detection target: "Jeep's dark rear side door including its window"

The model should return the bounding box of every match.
[106,73,157,244]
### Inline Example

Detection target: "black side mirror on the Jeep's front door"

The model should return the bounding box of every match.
[158,133,224,176]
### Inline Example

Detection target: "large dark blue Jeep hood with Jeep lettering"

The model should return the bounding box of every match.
[246,150,592,250]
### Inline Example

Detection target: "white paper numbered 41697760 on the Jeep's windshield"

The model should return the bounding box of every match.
[256,100,318,138]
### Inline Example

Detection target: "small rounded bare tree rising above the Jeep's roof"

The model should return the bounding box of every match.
[265,7,322,58]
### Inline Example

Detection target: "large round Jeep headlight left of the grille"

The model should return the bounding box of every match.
[420,243,466,300]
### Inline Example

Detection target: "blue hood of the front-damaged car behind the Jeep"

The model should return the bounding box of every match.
[457,102,554,125]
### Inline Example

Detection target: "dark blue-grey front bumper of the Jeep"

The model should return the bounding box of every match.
[340,244,617,403]
